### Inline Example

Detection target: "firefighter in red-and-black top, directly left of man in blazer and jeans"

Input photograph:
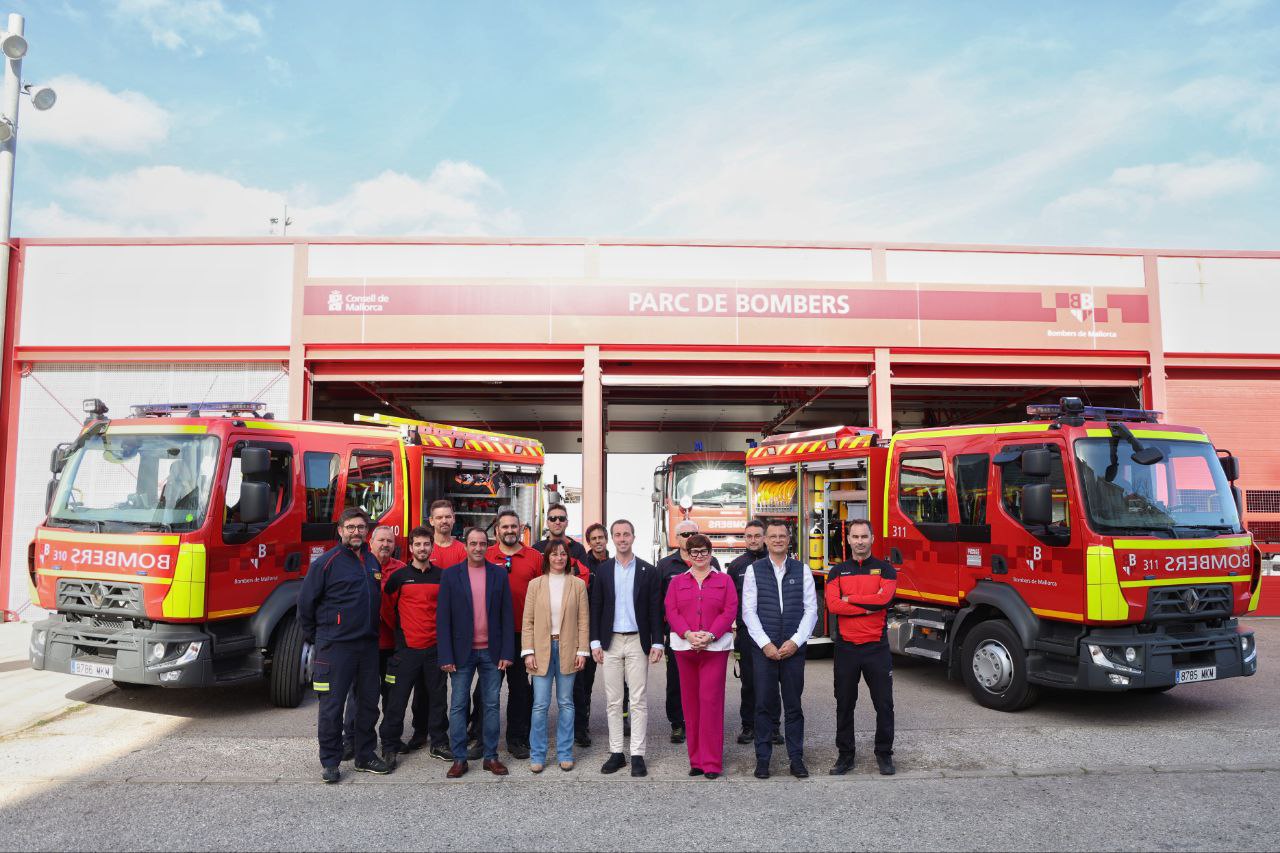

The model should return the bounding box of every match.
[379,528,453,763]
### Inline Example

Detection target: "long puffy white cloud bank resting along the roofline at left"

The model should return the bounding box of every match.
[15,161,520,237]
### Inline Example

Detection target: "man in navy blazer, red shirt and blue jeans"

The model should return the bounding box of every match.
[435,528,516,779]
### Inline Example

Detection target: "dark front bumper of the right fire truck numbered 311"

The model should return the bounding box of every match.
[1076,620,1258,690]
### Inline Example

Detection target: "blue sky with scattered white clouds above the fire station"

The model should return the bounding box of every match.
[10,0,1280,248]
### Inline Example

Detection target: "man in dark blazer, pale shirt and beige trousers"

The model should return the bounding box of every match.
[591,519,663,776]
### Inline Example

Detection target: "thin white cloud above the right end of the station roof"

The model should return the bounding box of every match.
[1047,158,1270,216]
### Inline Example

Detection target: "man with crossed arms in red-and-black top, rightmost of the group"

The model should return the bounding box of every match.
[826,519,897,776]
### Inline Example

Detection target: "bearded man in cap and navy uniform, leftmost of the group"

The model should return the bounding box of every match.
[298,507,390,783]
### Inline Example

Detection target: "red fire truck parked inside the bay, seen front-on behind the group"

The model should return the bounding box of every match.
[653,451,746,560]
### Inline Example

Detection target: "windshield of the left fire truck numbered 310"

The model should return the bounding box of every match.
[49,432,218,532]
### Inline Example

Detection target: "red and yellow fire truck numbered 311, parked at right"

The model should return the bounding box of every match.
[746,397,1261,711]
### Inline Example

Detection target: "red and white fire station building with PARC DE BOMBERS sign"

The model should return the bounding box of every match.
[0,237,1280,610]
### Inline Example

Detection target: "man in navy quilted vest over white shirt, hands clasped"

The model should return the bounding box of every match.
[742,521,818,779]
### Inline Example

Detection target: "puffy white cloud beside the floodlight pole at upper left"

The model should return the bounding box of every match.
[20,74,172,152]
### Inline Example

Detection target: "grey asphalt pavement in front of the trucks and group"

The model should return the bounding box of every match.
[0,620,1280,850]
